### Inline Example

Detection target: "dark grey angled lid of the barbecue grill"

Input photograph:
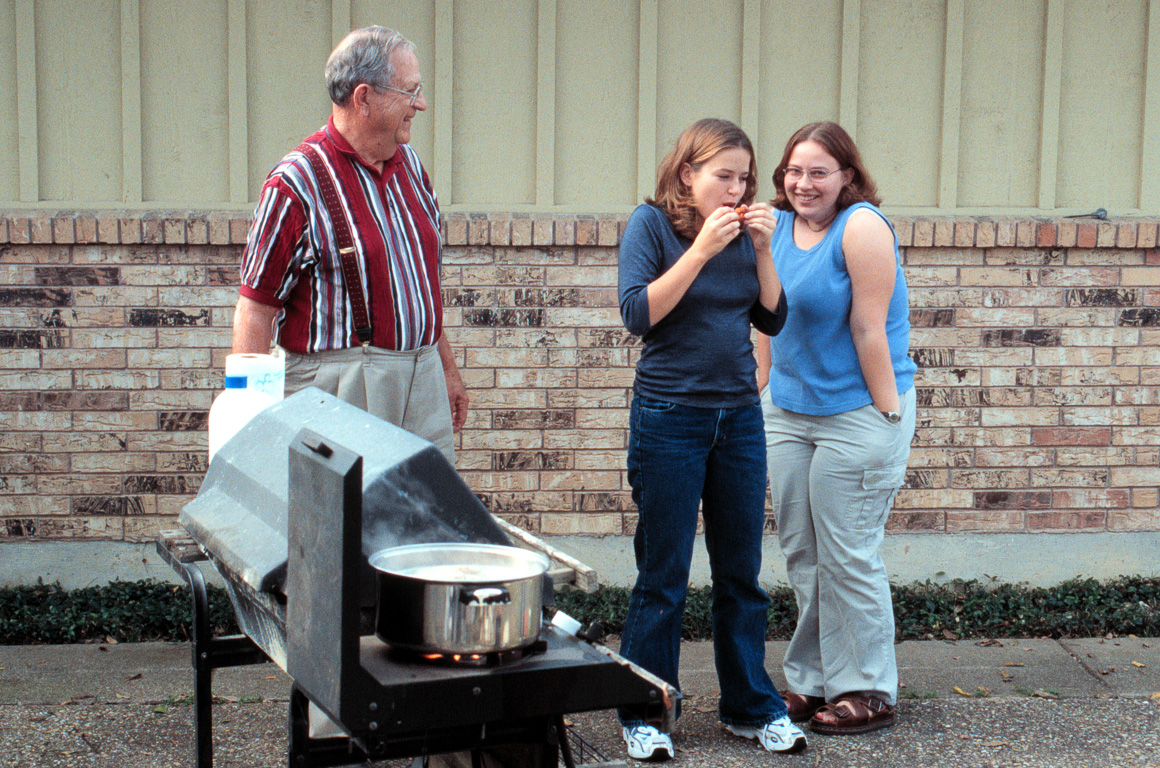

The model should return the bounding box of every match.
[179,387,512,593]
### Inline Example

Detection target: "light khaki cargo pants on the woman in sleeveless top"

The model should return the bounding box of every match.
[762,387,914,704]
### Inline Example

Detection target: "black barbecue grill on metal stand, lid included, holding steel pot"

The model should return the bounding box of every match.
[158,389,680,768]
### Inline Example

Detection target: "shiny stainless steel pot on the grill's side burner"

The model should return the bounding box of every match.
[370,543,549,654]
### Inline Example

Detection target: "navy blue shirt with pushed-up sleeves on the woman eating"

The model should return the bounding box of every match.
[617,205,785,408]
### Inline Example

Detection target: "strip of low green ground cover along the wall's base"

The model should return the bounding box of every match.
[0,577,1160,645]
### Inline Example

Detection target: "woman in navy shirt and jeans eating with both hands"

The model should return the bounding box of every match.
[618,119,805,761]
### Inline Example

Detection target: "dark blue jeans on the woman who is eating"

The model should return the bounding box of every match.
[619,396,785,727]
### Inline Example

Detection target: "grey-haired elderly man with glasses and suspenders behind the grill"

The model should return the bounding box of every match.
[233,27,467,461]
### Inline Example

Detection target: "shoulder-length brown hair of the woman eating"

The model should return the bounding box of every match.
[645,117,757,240]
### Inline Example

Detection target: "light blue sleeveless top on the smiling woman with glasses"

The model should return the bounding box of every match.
[769,203,918,415]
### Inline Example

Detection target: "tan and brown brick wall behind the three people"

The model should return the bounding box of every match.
[0,211,1160,542]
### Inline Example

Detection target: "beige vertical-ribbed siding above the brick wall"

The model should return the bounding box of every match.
[0,0,1160,213]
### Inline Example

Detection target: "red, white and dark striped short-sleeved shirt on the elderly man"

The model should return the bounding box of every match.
[241,119,443,354]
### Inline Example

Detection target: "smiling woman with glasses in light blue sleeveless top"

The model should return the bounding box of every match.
[757,123,915,734]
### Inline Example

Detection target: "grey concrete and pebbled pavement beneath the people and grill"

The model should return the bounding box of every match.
[0,638,1160,768]
